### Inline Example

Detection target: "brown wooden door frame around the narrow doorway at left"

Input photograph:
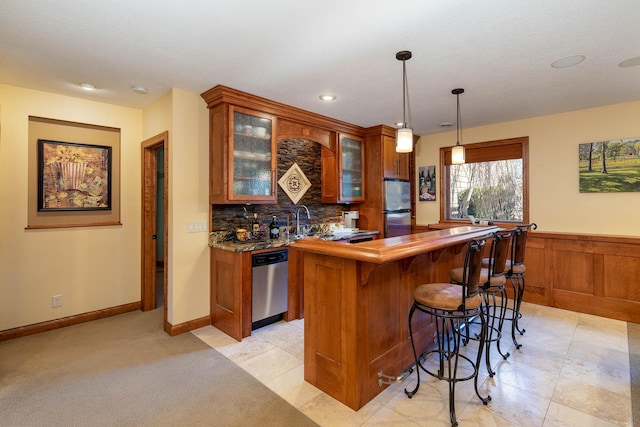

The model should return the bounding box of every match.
[140,131,169,330]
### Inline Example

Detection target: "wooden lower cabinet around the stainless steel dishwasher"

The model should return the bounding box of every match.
[210,247,302,341]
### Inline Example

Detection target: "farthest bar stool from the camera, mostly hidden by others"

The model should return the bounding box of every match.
[506,222,538,348]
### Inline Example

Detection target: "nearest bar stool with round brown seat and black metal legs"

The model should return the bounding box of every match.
[404,239,491,427]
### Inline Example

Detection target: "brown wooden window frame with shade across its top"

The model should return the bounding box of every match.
[440,136,529,227]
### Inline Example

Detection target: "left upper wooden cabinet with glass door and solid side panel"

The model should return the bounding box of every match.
[210,104,278,204]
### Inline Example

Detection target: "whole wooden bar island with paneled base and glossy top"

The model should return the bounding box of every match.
[289,226,497,410]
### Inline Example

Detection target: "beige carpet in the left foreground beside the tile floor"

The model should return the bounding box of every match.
[0,309,316,427]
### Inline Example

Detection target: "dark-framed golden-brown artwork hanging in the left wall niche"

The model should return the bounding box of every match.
[38,139,112,212]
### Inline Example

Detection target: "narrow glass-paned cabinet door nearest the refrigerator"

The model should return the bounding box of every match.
[338,135,364,203]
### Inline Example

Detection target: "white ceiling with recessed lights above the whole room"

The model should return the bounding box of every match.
[0,0,640,135]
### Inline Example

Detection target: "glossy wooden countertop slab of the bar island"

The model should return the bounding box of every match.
[295,226,497,264]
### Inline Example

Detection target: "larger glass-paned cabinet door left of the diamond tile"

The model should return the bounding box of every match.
[227,106,277,203]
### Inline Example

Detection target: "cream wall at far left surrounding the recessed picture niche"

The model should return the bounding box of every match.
[0,85,142,330]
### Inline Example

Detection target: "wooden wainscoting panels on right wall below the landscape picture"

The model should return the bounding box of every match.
[424,223,640,323]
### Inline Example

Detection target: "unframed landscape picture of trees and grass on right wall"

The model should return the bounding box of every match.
[578,137,640,193]
